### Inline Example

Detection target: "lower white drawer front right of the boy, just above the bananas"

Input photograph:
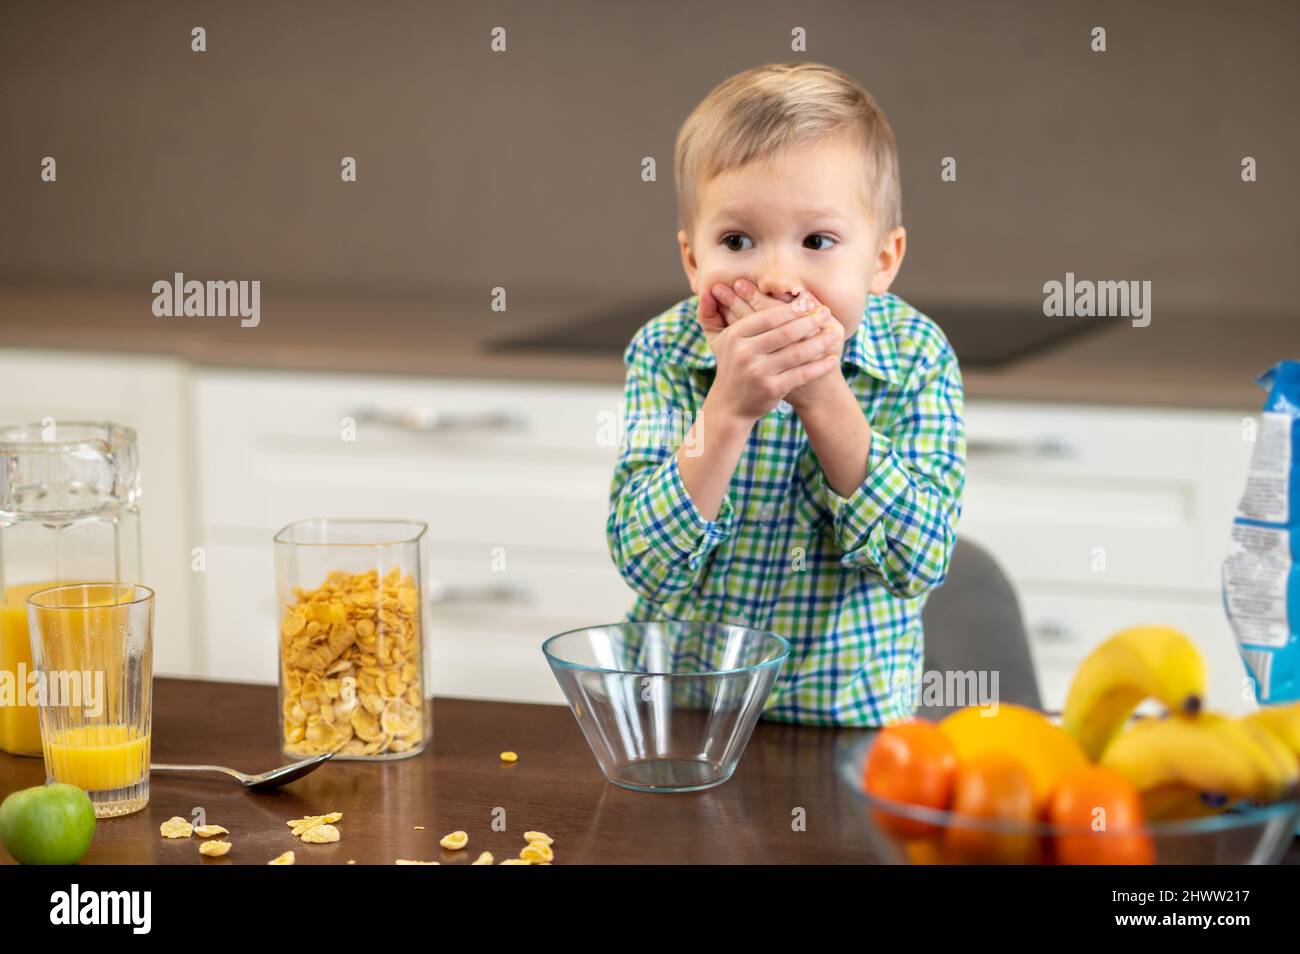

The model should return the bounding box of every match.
[1019,587,1253,712]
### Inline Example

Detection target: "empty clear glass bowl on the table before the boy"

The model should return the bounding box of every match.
[542,620,790,792]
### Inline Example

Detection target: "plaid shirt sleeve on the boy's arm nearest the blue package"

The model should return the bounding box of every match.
[814,334,966,598]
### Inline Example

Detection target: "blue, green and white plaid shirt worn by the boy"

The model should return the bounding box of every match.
[606,294,966,725]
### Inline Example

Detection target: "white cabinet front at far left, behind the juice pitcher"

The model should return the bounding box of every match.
[0,348,199,675]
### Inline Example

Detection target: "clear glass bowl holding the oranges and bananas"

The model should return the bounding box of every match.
[837,734,1300,864]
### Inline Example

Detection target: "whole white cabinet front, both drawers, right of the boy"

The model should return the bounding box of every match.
[959,403,1253,711]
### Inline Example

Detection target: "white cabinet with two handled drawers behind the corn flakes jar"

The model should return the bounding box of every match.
[195,370,633,702]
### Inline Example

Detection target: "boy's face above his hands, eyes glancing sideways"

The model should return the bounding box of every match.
[677,136,905,335]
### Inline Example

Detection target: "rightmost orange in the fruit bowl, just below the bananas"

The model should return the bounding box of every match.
[1048,766,1156,864]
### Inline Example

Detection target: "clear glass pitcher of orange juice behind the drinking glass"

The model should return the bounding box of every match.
[0,417,140,755]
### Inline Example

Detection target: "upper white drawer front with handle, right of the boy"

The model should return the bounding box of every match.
[961,404,1252,595]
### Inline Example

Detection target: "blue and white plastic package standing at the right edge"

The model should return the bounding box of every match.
[1223,361,1300,704]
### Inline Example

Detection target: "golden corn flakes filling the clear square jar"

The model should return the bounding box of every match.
[280,567,425,756]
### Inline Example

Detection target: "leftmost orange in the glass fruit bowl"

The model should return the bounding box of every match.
[862,719,957,838]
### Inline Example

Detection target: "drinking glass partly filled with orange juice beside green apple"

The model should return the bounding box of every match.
[27,582,153,818]
